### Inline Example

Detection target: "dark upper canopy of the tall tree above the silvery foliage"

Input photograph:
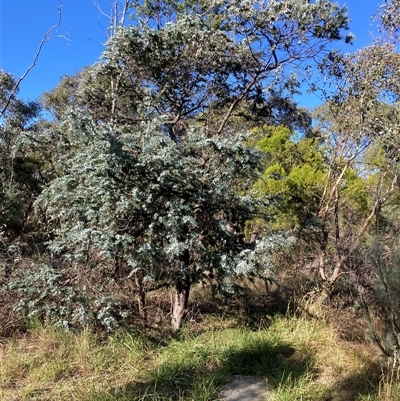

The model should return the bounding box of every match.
[81,0,351,136]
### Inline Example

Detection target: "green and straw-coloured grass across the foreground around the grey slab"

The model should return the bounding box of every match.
[0,317,388,401]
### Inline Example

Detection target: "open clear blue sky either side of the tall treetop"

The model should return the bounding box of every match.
[0,0,381,104]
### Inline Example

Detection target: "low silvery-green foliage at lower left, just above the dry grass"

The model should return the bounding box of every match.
[7,260,130,331]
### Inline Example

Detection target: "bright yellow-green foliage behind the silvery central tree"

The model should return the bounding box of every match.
[250,126,326,230]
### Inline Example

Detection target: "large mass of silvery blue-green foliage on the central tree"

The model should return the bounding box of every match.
[24,114,278,328]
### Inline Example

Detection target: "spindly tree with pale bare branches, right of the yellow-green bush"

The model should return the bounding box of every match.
[315,42,400,288]
